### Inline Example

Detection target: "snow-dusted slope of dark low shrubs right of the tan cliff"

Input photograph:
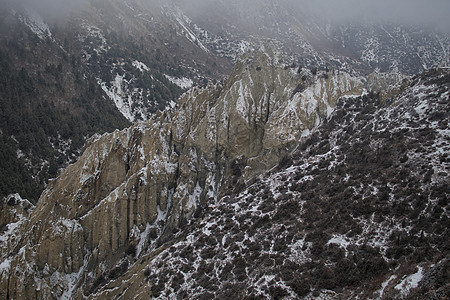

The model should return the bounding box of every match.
[91,70,450,299]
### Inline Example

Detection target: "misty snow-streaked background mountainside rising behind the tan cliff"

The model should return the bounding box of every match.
[0,0,450,202]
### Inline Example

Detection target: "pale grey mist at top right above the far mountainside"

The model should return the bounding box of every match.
[179,0,450,33]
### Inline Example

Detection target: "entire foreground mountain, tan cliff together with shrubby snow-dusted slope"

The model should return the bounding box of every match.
[0,45,450,299]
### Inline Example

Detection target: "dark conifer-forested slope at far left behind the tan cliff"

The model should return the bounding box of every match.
[0,9,129,202]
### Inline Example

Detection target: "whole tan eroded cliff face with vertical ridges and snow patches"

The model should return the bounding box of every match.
[0,47,370,299]
